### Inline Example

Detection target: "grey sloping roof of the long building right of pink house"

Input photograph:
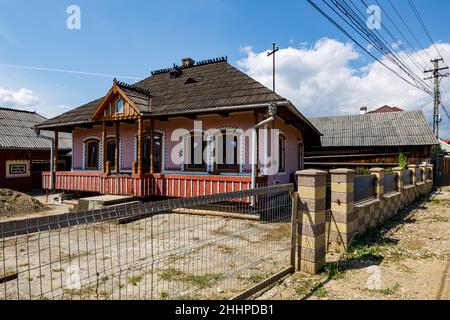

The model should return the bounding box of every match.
[310,111,439,147]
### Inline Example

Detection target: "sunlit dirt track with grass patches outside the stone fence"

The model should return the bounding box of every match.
[259,187,450,300]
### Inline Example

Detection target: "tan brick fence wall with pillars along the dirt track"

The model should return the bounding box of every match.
[297,165,433,273]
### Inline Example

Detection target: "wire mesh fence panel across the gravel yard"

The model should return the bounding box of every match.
[0,185,292,300]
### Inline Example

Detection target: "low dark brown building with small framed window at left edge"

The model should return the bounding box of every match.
[0,108,72,191]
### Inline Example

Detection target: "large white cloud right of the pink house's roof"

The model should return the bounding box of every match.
[238,38,450,136]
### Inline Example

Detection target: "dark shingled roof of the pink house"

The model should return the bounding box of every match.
[39,58,294,128]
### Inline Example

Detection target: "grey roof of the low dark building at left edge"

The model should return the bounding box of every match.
[0,108,72,150]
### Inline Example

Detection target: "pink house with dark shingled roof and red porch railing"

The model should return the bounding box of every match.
[38,58,320,197]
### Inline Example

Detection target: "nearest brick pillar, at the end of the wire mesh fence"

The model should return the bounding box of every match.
[296,170,327,274]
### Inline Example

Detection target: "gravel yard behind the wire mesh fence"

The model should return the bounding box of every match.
[0,214,290,300]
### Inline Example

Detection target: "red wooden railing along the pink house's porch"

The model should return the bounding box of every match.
[42,172,268,198]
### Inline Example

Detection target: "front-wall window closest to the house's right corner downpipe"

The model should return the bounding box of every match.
[217,131,239,172]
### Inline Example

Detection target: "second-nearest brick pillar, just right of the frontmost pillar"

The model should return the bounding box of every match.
[328,169,358,251]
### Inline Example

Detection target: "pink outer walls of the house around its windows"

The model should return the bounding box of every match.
[73,112,303,184]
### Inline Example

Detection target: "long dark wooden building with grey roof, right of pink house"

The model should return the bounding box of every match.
[305,111,439,169]
